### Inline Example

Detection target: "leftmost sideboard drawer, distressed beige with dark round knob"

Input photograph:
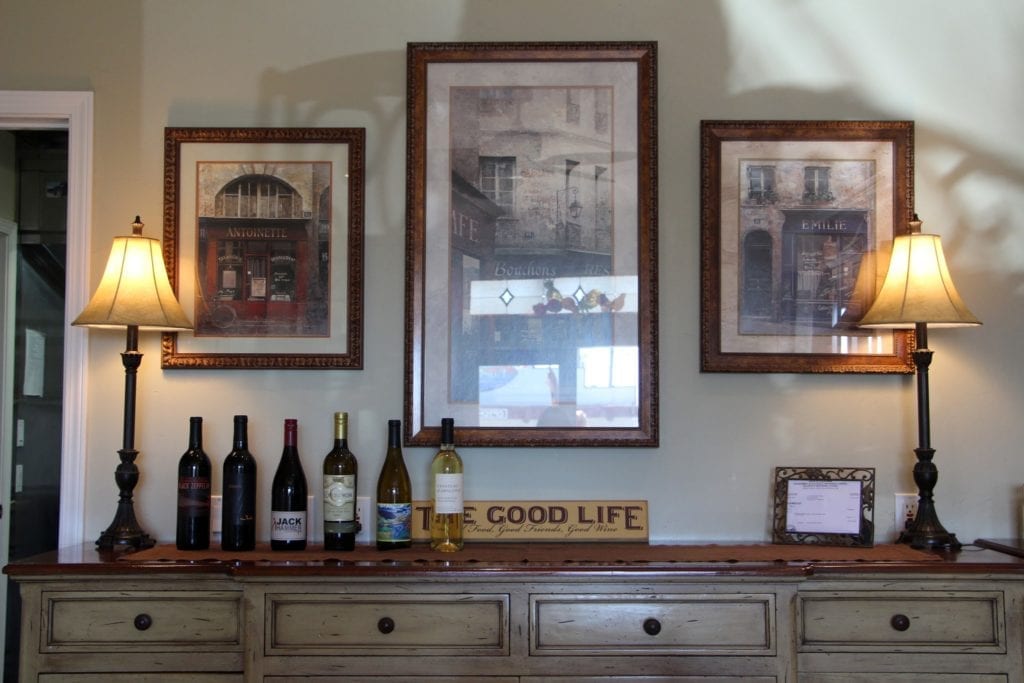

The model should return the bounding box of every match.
[40,591,242,652]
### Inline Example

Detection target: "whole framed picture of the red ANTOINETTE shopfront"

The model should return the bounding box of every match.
[161,128,366,370]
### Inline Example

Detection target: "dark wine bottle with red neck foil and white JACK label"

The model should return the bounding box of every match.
[270,419,306,550]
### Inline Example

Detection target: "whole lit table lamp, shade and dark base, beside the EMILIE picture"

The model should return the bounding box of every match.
[860,214,981,550]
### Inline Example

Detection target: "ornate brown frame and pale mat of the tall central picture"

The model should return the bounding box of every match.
[404,42,658,446]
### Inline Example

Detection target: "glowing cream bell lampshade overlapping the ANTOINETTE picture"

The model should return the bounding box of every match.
[72,216,193,330]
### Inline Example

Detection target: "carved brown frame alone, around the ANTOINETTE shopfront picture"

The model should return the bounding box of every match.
[161,128,366,370]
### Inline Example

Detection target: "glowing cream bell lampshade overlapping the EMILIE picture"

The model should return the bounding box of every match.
[860,222,981,328]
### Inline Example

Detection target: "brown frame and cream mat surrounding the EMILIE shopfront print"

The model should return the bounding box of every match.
[700,121,913,374]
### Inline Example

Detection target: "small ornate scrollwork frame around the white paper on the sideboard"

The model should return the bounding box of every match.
[772,467,874,547]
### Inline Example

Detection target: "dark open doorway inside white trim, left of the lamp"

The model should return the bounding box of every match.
[0,130,68,681]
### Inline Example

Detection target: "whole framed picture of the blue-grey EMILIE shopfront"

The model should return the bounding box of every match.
[700,121,913,373]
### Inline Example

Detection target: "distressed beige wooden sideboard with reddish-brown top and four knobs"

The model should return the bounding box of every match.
[5,545,1024,683]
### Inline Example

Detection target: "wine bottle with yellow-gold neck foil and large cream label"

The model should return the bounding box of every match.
[324,413,358,550]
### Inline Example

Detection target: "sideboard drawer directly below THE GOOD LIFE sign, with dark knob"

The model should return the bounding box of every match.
[530,593,775,655]
